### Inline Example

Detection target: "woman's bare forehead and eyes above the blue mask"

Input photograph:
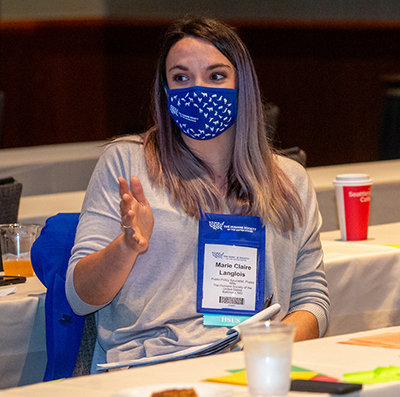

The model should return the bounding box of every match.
[165,37,236,90]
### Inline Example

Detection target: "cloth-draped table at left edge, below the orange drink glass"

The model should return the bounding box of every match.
[0,277,47,389]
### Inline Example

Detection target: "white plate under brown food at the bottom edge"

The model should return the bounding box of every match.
[113,382,232,397]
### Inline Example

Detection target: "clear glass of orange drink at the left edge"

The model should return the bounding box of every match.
[0,223,40,277]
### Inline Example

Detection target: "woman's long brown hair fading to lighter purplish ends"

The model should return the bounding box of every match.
[144,17,303,232]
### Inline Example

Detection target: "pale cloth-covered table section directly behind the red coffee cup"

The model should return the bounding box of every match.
[307,160,400,232]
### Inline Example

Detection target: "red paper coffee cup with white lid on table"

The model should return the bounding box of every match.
[333,174,372,241]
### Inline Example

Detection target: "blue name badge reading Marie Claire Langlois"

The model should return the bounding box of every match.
[197,213,265,318]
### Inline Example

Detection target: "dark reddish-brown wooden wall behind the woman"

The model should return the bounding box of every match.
[0,19,400,166]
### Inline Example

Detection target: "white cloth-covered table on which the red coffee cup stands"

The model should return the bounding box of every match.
[321,223,400,336]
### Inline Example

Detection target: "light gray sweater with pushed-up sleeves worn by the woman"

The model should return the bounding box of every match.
[66,138,329,369]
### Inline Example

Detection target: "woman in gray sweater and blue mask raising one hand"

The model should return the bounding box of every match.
[66,18,329,369]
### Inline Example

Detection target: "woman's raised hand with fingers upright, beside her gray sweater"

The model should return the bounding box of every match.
[118,176,154,253]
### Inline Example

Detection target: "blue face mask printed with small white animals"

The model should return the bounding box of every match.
[167,86,237,140]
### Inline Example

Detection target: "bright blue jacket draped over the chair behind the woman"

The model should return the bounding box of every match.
[31,213,85,381]
